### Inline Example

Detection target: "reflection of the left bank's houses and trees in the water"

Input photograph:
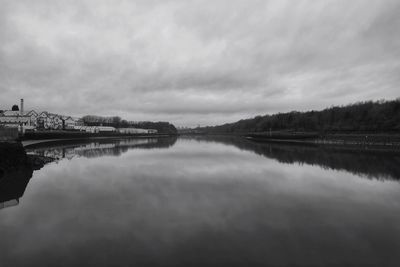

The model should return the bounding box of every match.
[29,137,176,159]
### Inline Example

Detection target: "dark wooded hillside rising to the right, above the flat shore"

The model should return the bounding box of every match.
[199,98,400,134]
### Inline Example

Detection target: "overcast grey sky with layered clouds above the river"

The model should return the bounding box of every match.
[0,0,400,126]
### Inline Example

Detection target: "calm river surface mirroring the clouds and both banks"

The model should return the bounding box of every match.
[0,138,400,267]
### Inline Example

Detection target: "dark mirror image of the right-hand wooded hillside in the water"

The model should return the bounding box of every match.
[187,136,400,180]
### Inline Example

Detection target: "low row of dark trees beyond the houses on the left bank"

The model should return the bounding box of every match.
[82,115,177,134]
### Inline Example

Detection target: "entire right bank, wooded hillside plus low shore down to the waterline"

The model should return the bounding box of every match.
[190,98,400,149]
